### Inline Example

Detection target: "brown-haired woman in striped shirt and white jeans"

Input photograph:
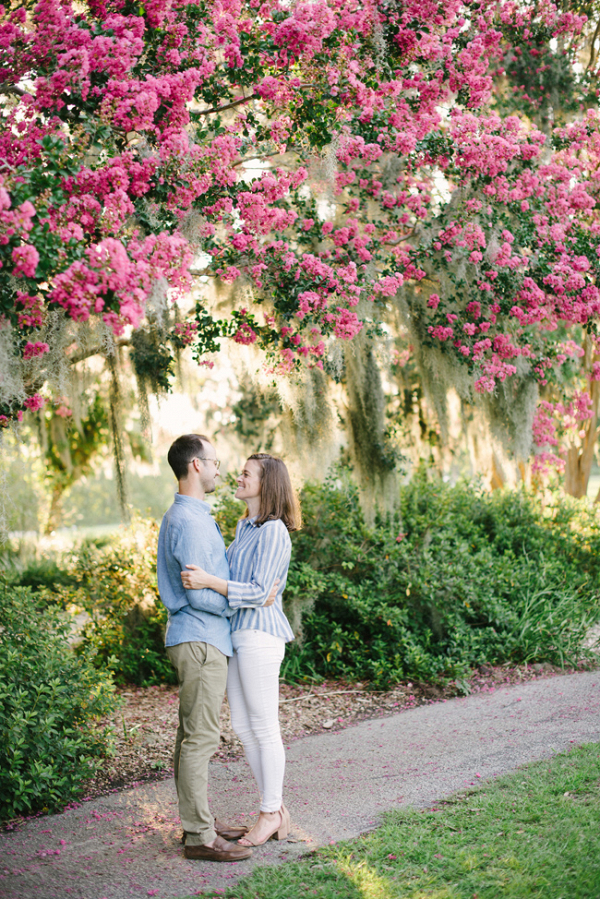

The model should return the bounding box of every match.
[181,453,301,846]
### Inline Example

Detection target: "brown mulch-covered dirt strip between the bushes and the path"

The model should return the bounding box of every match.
[85,664,566,799]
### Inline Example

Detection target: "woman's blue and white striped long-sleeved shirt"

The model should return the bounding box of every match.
[227,518,294,643]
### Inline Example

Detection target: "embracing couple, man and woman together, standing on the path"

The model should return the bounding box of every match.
[157,434,300,862]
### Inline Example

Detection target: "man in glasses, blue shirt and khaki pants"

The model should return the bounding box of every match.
[157,434,252,862]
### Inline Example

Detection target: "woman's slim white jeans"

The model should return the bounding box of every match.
[227,629,285,812]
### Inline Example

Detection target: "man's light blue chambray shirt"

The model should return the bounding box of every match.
[156,493,234,656]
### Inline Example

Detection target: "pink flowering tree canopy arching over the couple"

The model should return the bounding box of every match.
[0,0,600,492]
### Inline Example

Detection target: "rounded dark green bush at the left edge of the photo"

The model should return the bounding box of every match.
[0,584,116,820]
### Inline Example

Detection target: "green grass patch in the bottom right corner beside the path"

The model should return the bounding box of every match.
[188,744,600,899]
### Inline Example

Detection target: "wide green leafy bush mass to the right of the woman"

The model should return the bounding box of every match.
[286,472,600,686]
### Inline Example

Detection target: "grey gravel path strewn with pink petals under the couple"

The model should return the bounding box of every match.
[0,671,600,899]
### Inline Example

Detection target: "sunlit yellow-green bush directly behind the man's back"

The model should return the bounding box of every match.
[57,521,176,686]
